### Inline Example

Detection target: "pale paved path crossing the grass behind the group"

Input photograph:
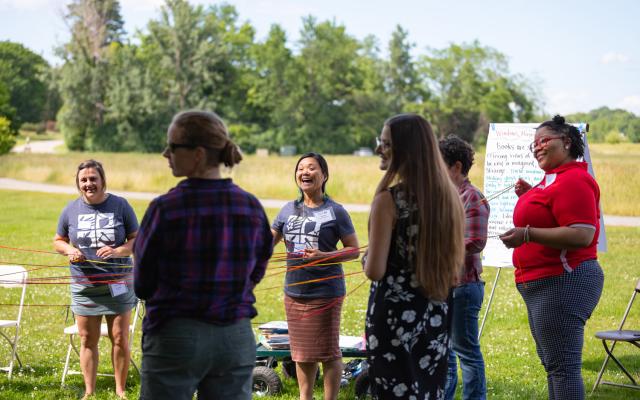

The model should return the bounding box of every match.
[0,178,640,226]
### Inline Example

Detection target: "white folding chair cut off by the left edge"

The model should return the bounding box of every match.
[0,265,27,379]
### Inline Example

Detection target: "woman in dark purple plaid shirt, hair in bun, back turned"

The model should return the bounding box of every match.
[134,111,272,400]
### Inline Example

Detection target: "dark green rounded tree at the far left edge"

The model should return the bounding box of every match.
[0,41,49,130]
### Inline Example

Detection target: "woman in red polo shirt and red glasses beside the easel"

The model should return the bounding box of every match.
[500,115,604,400]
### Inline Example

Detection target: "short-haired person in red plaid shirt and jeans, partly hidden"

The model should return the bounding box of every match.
[440,135,489,400]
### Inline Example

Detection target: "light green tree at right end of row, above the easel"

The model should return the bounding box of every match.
[420,41,535,141]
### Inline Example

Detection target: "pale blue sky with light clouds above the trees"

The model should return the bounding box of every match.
[0,0,640,116]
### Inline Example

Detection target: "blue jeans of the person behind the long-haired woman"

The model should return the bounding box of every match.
[445,282,487,400]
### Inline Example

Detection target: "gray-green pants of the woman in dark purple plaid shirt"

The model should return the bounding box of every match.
[140,318,256,400]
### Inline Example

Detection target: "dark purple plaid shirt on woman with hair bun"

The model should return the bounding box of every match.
[134,178,272,333]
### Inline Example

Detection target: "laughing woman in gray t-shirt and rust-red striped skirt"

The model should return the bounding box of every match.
[271,153,358,400]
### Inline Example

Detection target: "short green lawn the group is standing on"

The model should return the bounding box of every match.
[0,190,640,400]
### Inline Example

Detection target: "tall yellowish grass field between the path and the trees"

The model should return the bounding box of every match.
[0,144,640,216]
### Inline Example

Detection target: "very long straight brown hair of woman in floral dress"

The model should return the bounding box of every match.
[376,114,465,300]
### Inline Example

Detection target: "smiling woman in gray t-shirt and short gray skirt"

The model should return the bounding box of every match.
[53,160,138,398]
